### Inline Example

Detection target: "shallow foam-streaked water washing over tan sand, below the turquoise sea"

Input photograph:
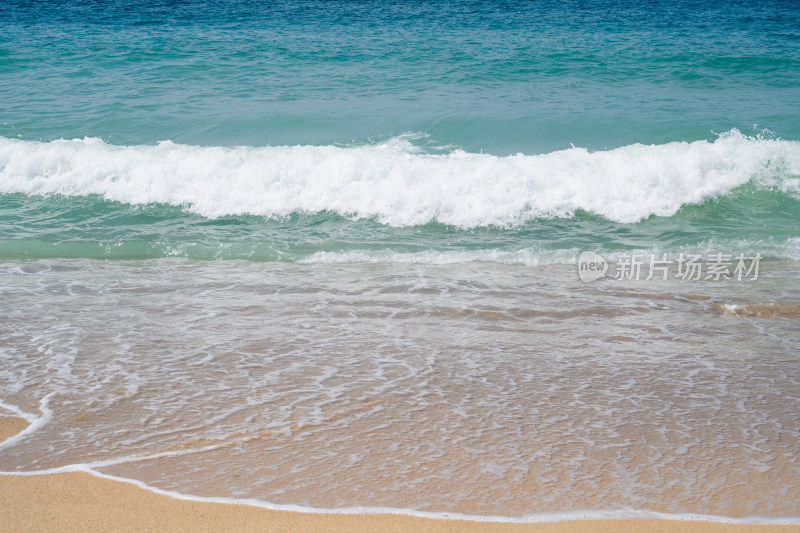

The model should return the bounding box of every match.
[0,260,800,518]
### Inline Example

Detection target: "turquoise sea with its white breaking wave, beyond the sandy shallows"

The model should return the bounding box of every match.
[0,1,800,262]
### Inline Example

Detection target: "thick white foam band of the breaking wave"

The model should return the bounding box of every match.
[0,130,800,227]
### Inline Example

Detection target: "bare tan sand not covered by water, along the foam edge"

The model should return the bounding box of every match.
[0,417,800,533]
